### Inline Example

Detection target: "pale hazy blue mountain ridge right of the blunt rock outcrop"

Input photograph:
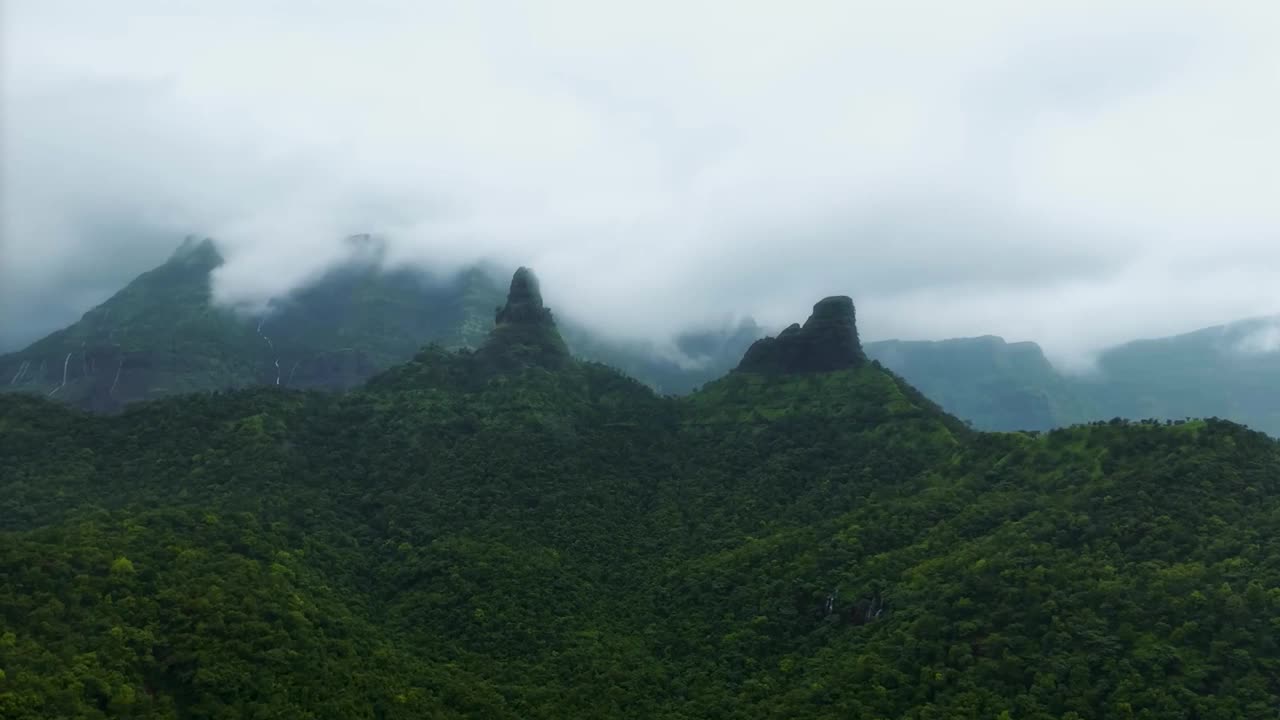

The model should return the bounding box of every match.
[867,316,1280,436]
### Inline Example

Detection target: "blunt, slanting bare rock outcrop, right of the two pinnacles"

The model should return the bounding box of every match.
[737,295,867,374]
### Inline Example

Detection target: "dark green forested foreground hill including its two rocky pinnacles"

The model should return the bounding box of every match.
[0,272,1280,720]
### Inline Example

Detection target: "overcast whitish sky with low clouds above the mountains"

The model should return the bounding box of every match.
[0,0,1280,363]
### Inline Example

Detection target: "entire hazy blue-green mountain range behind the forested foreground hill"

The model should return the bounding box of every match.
[0,236,1280,436]
